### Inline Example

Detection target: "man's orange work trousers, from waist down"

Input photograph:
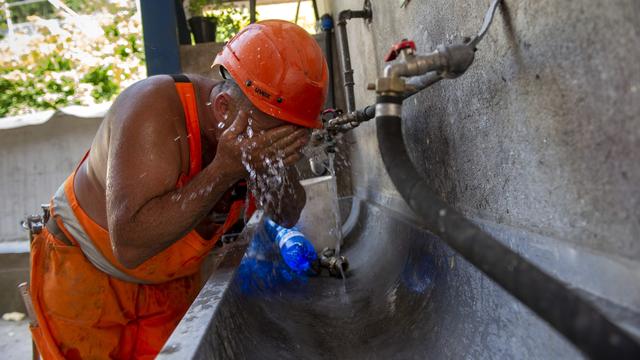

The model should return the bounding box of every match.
[31,229,201,360]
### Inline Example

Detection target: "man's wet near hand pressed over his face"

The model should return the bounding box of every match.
[212,111,309,179]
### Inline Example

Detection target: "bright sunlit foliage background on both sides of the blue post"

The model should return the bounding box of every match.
[0,0,316,117]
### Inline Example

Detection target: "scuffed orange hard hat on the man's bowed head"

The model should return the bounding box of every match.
[213,20,329,128]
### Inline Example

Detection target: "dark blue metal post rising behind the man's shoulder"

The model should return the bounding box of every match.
[140,0,182,76]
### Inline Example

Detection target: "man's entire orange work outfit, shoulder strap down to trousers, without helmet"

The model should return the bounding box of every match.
[30,77,250,360]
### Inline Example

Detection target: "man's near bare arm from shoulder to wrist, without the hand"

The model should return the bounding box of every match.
[106,80,239,268]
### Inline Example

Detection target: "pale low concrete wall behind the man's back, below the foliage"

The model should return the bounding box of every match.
[0,115,102,242]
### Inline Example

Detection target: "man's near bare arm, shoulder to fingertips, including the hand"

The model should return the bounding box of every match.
[107,81,304,268]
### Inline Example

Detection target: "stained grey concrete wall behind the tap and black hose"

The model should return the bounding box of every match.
[333,0,640,356]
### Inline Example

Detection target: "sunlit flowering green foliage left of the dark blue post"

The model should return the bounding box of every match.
[0,0,145,117]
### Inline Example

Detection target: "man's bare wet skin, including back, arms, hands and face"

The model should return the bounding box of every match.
[74,75,309,268]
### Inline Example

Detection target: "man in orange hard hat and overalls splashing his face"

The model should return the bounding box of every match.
[30,20,328,359]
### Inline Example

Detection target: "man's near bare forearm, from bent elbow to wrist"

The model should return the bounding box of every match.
[110,163,238,267]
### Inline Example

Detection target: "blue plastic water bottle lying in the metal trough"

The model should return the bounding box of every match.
[264,219,319,273]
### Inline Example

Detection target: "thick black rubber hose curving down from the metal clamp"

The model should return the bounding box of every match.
[376,112,640,359]
